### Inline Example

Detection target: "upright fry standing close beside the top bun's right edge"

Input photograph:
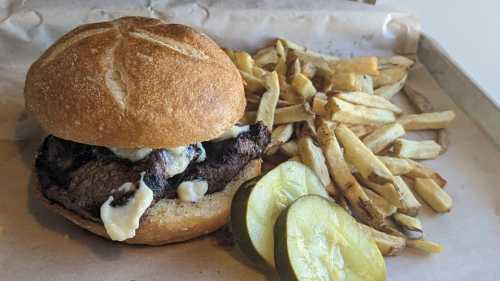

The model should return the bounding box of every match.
[256,72,280,130]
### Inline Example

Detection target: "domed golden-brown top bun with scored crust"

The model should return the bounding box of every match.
[24,17,246,148]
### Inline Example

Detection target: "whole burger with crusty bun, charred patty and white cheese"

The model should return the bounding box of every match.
[24,17,270,245]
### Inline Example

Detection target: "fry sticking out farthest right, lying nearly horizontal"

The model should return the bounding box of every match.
[398,110,455,131]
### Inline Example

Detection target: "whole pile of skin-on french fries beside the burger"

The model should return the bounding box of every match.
[225,39,455,256]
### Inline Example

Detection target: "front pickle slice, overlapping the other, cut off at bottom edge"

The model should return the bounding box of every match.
[274,195,386,281]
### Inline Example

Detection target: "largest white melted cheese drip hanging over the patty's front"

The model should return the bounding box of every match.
[101,172,153,241]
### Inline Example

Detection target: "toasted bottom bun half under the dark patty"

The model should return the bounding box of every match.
[31,160,261,245]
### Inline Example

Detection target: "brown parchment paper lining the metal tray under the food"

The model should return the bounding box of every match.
[0,0,500,281]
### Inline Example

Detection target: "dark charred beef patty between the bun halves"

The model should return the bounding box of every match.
[35,123,271,221]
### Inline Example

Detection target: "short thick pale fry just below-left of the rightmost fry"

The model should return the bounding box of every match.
[363,123,406,153]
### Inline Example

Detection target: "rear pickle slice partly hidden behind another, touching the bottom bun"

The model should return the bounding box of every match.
[231,161,328,268]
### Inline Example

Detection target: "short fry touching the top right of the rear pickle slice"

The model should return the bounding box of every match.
[297,136,332,187]
